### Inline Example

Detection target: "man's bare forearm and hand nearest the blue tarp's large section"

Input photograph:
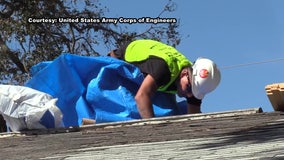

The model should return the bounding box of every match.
[135,74,157,118]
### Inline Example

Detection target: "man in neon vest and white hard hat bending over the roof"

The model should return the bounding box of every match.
[108,40,221,118]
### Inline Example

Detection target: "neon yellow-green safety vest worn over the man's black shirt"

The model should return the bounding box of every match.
[124,40,192,93]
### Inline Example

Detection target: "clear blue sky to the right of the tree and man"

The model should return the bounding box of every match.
[98,0,284,113]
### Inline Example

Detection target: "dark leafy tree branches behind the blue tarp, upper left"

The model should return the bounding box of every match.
[0,0,180,84]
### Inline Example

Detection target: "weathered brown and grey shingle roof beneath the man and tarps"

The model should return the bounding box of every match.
[0,108,284,160]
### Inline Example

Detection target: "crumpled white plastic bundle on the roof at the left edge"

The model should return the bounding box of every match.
[0,85,63,131]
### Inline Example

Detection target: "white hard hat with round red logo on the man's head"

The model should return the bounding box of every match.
[191,58,221,99]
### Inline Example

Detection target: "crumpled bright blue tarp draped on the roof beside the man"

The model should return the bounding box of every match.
[26,54,186,127]
